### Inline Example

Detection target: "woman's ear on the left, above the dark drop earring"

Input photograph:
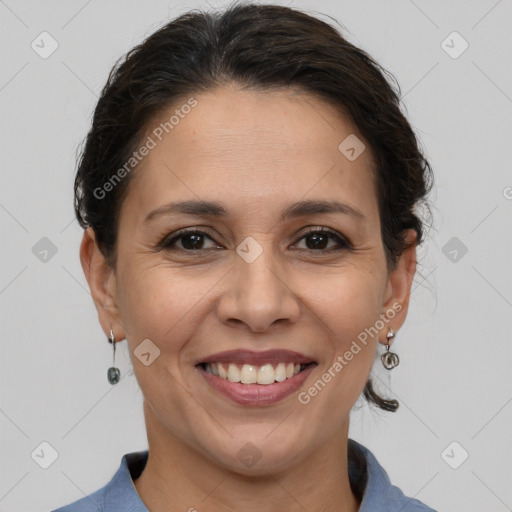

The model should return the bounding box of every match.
[80,227,126,341]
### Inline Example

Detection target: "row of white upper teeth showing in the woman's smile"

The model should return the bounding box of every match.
[205,363,306,385]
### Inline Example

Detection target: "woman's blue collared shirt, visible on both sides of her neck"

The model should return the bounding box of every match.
[53,439,436,512]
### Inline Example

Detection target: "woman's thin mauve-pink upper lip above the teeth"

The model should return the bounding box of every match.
[196,349,315,366]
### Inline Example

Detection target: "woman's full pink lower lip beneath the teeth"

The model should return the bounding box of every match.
[196,364,316,405]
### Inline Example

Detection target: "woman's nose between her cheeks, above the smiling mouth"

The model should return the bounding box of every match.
[217,247,300,332]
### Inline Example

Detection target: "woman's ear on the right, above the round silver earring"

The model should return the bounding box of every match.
[379,229,417,345]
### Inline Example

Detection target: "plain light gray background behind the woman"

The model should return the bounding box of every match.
[0,0,512,512]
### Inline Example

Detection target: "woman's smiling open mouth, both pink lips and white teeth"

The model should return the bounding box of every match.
[195,349,318,405]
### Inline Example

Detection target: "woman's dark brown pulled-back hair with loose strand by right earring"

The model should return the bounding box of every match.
[75,4,432,411]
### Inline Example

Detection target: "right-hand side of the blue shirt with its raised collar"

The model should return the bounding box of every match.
[348,439,436,512]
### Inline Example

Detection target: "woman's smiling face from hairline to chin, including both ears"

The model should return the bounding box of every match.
[82,86,415,474]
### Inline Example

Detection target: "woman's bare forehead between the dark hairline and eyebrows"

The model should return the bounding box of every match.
[121,86,376,222]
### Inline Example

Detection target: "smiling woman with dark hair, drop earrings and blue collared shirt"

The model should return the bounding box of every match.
[53,5,433,512]
